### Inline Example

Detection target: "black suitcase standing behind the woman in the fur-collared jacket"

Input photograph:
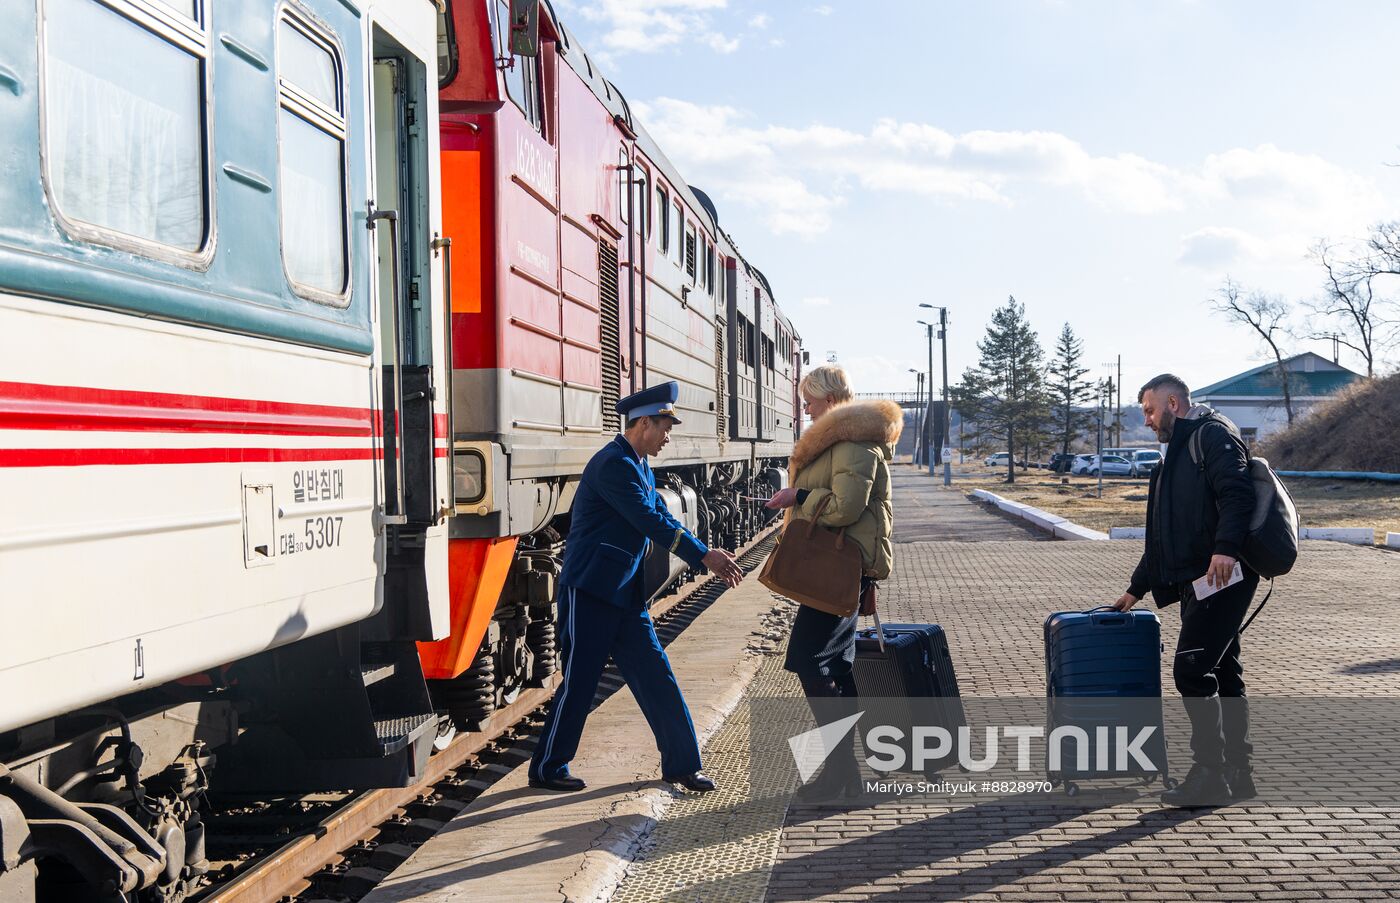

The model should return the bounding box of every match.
[853,617,967,776]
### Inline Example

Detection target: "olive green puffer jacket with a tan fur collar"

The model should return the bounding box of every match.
[788,400,904,580]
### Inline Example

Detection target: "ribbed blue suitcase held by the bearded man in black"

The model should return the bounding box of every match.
[1044,609,1173,797]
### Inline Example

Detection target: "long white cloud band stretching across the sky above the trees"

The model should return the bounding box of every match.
[638,98,1385,243]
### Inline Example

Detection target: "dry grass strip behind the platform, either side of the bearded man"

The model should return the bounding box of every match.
[958,466,1400,542]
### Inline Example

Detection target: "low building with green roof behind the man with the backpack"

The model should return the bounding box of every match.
[1191,351,1364,442]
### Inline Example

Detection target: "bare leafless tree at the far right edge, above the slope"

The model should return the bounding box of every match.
[1308,239,1400,377]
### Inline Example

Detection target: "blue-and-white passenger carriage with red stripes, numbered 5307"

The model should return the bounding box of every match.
[0,0,451,900]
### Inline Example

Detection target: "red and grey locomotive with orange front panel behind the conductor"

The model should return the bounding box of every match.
[420,0,802,727]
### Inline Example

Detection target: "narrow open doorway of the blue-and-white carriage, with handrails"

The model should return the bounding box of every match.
[370,28,445,640]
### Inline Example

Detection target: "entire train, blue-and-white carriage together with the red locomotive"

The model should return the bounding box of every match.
[0,0,802,900]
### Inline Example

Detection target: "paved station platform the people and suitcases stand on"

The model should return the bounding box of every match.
[370,468,1400,903]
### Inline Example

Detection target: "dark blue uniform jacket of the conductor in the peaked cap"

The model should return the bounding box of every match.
[559,435,710,606]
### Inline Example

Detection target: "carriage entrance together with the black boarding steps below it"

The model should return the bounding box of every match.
[220,1,448,791]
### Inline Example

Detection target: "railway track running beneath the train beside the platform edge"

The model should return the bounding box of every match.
[195,528,776,903]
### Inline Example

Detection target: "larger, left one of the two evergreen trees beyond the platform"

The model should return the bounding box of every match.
[952,297,1050,483]
